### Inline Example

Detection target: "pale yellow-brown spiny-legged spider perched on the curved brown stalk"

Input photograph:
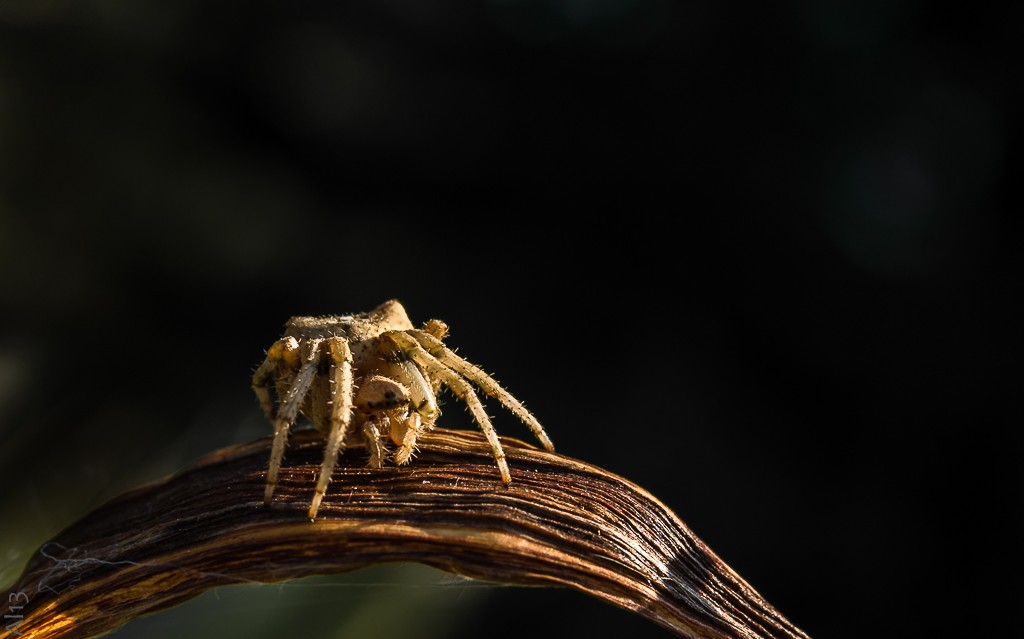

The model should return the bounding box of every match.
[253,300,554,521]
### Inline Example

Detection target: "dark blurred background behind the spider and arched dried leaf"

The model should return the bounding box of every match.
[0,0,1024,638]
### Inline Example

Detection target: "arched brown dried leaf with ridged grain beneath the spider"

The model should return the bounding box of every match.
[0,429,806,639]
